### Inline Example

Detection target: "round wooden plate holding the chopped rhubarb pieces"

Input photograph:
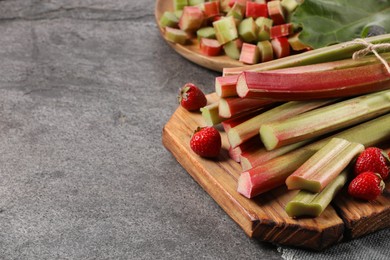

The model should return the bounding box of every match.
[155,0,244,72]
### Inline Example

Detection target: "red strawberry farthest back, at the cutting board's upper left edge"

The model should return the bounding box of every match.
[178,83,207,111]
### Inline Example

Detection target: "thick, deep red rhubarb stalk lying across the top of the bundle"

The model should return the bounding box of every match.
[237,63,390,101]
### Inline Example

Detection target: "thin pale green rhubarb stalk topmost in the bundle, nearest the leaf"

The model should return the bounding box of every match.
[223,34,390,76]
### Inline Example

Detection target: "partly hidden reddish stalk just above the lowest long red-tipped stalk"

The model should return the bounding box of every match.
[240,140,311,171]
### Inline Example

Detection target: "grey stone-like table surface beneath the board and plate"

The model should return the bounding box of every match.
[0,0,389,259]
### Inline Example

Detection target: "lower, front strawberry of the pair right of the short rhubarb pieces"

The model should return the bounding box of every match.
[348,172,385,200]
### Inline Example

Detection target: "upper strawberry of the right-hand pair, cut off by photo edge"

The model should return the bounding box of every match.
[355,147,390,180]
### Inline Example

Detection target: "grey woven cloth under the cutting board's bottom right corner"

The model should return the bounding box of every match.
[278,229,390,260]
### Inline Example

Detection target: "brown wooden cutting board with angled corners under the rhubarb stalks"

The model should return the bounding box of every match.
[162,94,390,250]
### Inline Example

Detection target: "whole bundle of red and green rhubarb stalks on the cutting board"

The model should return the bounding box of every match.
[194,34,390,217]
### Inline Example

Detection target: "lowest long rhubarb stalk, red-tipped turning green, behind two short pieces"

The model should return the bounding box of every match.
[237,114,390,198]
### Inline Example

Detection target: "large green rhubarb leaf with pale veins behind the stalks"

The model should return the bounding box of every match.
[291,0,390,49]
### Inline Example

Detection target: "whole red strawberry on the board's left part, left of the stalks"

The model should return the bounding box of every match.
[190,127,222,157]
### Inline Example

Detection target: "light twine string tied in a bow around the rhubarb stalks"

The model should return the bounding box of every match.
[345,39,390,74]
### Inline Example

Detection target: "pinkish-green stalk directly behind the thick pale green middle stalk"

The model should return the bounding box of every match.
[227,100,335,147]
